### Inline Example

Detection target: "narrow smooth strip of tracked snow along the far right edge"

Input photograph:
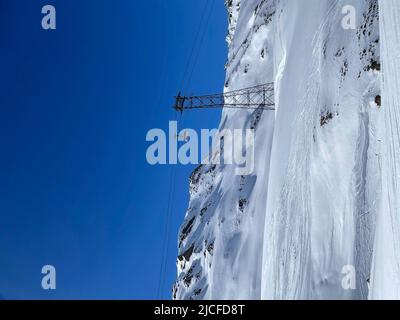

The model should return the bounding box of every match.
[370,0,400,299]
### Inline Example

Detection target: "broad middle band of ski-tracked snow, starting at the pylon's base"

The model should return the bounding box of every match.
[262,0,380,299]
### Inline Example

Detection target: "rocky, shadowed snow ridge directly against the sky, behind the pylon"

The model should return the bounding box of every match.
[174,0,275,299]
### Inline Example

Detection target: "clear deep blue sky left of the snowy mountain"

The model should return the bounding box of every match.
[0,0,227,299]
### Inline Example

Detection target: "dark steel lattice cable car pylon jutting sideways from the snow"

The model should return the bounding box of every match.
[173,83,275,112]
